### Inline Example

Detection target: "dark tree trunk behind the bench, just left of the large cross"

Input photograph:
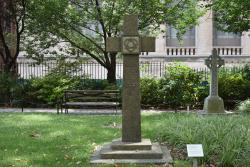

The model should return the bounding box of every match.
[107,53,116,84]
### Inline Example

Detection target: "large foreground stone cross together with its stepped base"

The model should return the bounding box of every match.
[91,15,172,164]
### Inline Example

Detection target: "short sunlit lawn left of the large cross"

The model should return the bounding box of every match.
[0,113,125,167]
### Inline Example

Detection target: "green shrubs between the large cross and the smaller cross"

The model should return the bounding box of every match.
[141,63,204,110]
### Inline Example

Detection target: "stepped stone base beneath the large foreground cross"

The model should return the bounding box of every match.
[90,139,173,164]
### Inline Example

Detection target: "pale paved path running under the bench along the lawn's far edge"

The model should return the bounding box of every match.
[0,108,171,115]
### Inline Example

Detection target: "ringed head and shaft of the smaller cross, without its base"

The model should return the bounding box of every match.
[205,49,225,96]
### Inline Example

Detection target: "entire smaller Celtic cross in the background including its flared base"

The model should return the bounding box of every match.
[203,49,225,114]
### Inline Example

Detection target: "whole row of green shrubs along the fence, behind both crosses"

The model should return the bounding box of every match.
[0,60,250,110]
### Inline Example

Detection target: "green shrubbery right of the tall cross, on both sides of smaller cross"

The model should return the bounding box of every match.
[141,63,250,109]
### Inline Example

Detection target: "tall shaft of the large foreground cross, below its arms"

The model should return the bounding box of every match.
[122,55,141,142]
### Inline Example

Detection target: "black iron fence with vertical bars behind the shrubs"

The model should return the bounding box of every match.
[0,62,245,79]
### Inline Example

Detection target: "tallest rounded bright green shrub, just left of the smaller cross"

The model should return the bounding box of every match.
[160,63,202,110]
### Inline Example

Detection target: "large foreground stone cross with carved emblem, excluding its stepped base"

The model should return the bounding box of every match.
[106,15,155,142]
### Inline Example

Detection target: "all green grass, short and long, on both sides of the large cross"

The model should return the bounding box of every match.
[0,113,250,167]
